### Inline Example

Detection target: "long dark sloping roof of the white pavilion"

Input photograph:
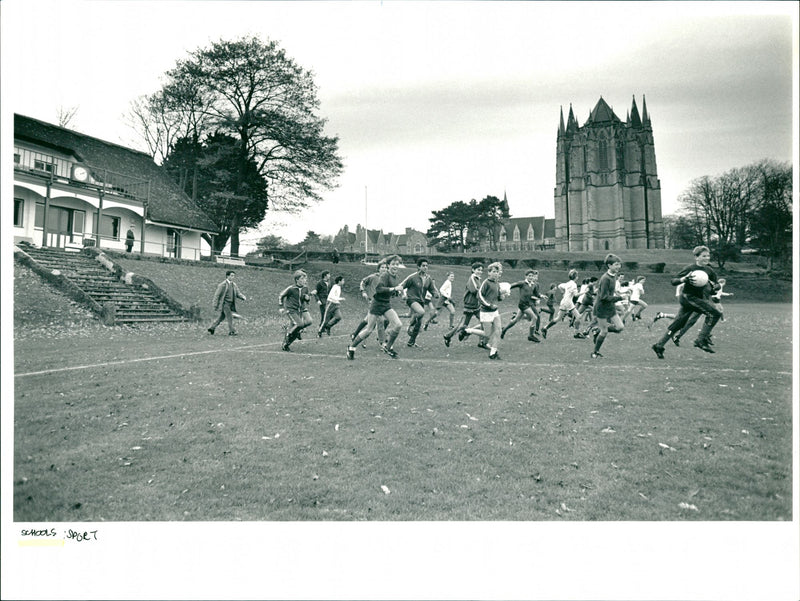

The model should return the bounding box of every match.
[14,114,219,232]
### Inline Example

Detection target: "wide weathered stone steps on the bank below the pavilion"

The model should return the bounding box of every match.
[21,245,189,325]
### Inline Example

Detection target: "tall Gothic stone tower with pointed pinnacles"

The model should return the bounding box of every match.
[554,96,664,251]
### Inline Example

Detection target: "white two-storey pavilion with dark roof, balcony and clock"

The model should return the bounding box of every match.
[14,115,217,260]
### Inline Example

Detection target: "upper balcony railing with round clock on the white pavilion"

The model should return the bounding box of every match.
[14,146,150,202]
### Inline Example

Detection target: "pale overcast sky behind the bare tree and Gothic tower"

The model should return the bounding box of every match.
[2,0,797,247]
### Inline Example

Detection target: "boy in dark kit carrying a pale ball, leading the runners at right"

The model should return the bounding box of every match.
[651,246,722,359]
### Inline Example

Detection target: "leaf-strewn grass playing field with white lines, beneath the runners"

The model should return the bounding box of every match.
[14,262,792,522]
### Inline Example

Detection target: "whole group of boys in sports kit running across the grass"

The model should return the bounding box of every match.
[278,246,730,360]
